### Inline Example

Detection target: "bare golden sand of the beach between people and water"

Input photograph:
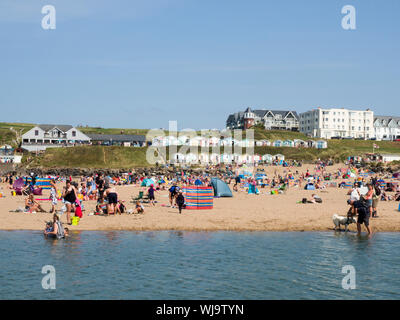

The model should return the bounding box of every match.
[0,166,400,232]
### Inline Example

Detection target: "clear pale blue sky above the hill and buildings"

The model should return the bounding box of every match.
[0,0,400,129]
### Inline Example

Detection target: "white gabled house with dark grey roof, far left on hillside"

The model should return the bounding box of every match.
[21,124,90,151]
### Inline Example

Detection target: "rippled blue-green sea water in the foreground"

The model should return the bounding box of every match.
[0,231,400,299]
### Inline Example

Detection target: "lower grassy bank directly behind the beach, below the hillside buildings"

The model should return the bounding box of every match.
[24,140,400,169]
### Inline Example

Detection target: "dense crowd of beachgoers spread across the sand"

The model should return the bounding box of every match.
[1,161,400,236]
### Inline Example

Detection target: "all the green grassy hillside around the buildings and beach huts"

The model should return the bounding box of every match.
[0,123,400,168]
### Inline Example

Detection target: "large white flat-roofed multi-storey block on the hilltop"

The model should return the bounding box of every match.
[299,108,375,139]
